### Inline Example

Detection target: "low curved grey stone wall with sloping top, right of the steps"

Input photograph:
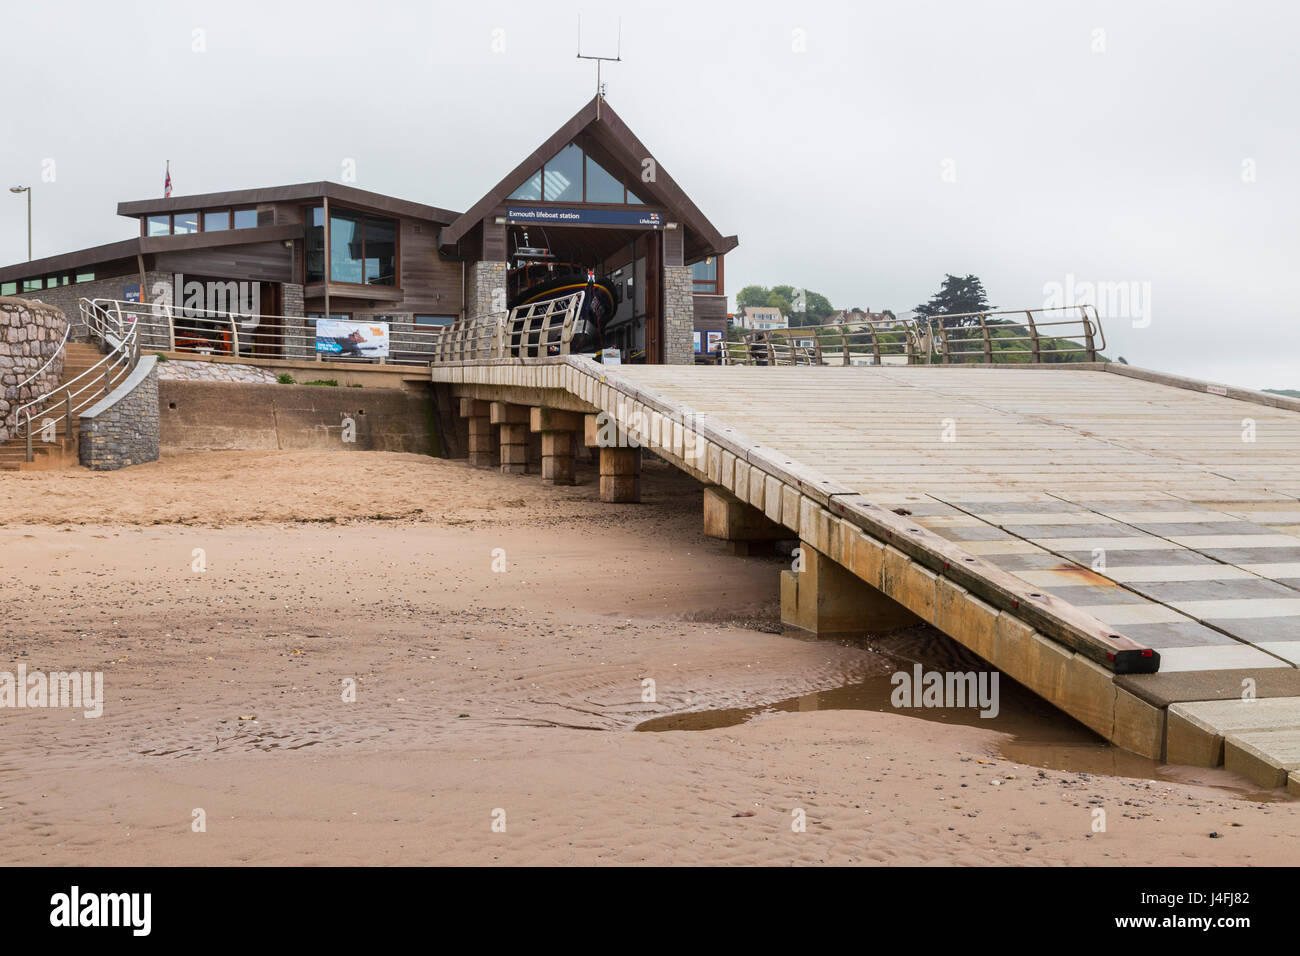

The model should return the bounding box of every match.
[78,355,159,471]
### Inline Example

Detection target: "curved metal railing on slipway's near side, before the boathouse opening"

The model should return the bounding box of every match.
[432,293,582,364]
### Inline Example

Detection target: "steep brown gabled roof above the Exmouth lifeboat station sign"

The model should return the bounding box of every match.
[442,96,740,258]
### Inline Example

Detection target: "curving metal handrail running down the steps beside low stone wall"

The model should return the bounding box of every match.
[17,299,140,462]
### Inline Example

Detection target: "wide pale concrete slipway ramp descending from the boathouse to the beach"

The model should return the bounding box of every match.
[432,355,1300,787]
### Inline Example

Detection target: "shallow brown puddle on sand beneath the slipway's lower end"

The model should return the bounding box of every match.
[636,627,1291,801]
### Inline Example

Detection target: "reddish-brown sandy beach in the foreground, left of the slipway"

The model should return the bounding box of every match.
[0,453,1300,865]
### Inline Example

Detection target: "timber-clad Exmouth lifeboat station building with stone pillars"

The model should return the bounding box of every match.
[0,96,737,364]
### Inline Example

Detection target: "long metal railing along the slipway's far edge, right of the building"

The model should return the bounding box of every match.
[718,306,1106,365]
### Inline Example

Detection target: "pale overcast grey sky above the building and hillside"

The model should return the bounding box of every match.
[0,0,1300,389]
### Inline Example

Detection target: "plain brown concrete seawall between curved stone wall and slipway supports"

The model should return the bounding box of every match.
[159,381,438,454]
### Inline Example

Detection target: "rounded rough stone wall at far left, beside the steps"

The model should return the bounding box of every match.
[0,297,68,441]
